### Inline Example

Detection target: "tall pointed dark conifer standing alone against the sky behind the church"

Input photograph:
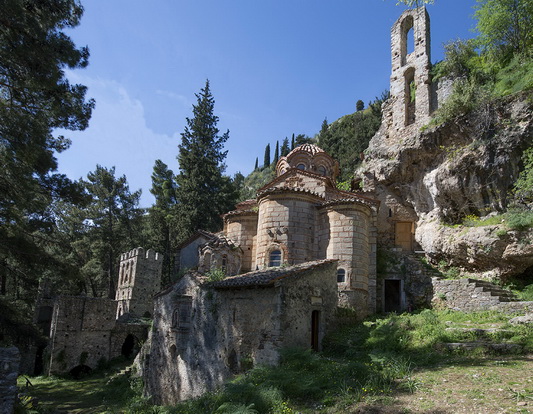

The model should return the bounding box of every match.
[176,80,237,240]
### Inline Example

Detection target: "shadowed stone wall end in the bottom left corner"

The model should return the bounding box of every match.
[0,347,20,414]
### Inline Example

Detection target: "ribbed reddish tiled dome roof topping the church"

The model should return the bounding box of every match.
[276,144,339,180]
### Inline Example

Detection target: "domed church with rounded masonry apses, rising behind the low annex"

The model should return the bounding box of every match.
[180,144,379,315]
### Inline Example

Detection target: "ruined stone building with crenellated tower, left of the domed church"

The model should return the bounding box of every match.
[35,248,162,376]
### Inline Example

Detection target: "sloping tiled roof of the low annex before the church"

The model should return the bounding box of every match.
[209,259,336,289]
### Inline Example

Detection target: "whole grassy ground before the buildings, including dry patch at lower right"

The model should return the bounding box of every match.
[20,310,533,414]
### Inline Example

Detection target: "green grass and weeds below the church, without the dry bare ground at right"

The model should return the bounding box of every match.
[19,310,533,414]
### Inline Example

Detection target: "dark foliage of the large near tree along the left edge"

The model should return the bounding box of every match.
[0,0,94,342]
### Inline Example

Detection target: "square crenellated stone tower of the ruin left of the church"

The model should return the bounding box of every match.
[115,247,163,319]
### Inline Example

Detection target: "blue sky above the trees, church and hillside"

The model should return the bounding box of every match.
[58,0,475,207]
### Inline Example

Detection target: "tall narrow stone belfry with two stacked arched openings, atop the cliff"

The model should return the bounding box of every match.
[390,7,432,131]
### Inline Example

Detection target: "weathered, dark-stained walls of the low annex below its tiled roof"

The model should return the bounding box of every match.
[137,262,337,404]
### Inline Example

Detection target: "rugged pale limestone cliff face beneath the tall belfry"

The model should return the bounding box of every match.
[357,94,533,277]
